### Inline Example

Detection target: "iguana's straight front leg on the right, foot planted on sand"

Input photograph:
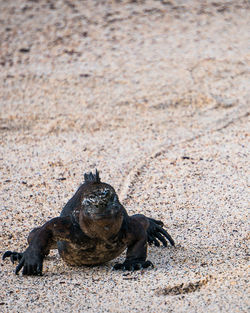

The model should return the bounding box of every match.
[114,217,153,271]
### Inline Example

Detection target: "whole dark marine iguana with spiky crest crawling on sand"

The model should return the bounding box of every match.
[3,171,174,275]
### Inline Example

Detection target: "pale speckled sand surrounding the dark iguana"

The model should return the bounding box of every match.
[0,0,250,312]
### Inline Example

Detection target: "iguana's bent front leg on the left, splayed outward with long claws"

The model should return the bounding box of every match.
[3,217,72,275]
